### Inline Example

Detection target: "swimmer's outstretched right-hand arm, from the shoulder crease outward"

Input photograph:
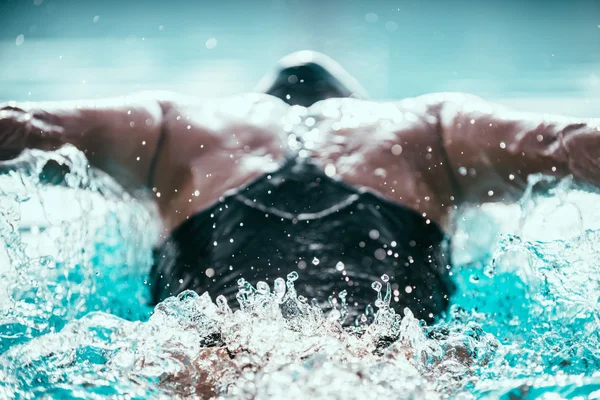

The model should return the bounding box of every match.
[436,93,600,202]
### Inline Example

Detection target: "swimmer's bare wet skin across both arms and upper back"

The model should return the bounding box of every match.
[0,92,600,236]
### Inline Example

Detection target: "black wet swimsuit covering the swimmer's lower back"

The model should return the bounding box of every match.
[151,152,454,321]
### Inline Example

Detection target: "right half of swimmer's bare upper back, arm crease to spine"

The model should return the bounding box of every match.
[309,98,454,228]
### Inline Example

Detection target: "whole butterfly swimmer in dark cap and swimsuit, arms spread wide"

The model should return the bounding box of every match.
[0,51,600,321]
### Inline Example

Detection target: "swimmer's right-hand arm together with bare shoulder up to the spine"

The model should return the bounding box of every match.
[311,93,600,230]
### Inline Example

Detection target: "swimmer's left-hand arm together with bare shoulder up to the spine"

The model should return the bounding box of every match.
[0,91,288,226]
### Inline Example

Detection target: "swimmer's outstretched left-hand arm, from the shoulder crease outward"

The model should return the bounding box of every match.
[0,93,171,189]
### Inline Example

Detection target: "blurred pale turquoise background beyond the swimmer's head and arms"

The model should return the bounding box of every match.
[0,0,600,117]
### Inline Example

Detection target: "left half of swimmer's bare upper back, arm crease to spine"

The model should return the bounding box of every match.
[152,94,289,229]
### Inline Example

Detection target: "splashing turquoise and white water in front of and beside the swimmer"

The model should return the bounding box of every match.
[0,148,600,399]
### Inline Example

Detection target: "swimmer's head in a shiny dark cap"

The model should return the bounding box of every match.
[257,50,367,107]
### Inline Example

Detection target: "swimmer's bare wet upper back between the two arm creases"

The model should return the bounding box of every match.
[152,95,453,236]
